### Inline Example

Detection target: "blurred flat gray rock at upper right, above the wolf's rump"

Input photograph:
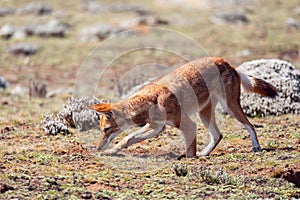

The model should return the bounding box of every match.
[210,11,249,24]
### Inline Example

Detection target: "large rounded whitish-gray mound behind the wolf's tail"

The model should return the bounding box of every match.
[238,59,300,116]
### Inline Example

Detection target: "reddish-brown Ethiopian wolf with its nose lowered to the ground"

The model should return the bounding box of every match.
[90,57,277,158]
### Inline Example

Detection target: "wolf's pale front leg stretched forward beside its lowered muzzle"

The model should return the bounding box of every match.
[103,123,165,155]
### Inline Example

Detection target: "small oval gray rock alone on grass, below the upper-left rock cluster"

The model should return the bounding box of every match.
[7,43,39,56]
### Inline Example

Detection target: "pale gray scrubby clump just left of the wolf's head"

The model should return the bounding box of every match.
[41,97,99,134]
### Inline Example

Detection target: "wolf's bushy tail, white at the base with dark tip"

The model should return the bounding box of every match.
[238,71,278,98]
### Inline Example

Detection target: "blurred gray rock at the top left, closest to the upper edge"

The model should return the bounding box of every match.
[15,2,52,15]
